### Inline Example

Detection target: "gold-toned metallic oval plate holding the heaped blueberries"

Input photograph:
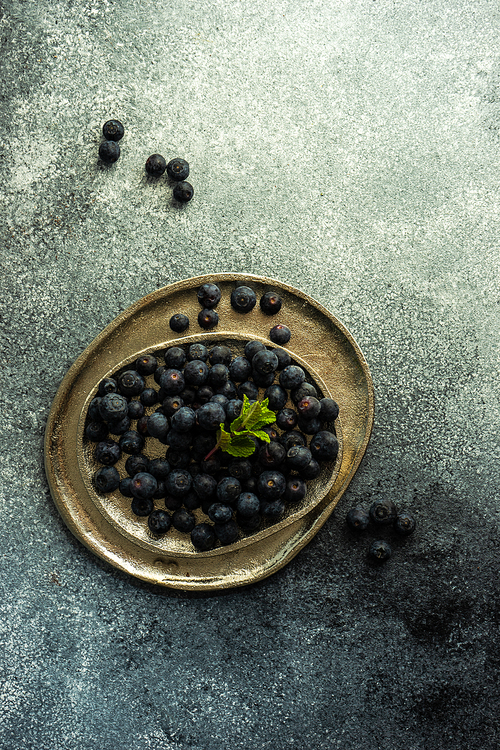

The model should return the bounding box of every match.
[45,273,373,590]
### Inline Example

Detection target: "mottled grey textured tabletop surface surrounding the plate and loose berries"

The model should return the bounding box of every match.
[0,0,500,750]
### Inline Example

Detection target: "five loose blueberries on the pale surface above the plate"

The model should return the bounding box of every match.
[99,120,194,203]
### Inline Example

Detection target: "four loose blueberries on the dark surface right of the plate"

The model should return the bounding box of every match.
[346,497,416,563]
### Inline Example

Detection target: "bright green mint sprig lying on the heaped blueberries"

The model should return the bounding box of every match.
[205,396,276,460]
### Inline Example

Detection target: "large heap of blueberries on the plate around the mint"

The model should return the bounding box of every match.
[85,284,339,551]
